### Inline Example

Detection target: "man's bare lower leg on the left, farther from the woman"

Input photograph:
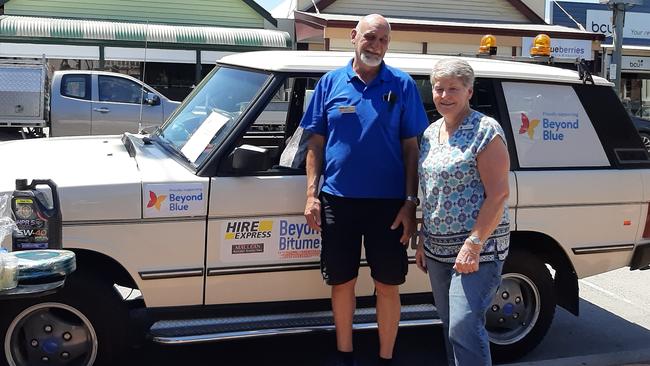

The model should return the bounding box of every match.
[332,278,357,352]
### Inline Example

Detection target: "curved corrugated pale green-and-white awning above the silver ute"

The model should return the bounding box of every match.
[0,15,291,48]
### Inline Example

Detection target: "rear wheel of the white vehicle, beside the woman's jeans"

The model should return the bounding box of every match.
[486,251,556,361]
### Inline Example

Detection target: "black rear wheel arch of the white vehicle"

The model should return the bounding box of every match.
[510,231,580,316]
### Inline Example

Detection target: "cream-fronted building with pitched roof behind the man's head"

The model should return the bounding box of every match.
[294,0,604,68]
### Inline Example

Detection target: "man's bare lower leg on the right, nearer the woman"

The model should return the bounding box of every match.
[375,281,401,359]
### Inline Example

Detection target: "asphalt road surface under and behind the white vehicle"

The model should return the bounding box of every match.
[124,268,650,366]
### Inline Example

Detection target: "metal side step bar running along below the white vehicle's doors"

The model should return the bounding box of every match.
[149,304,441,344]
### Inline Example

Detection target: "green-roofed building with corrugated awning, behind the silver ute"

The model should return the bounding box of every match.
[0,0,292,100]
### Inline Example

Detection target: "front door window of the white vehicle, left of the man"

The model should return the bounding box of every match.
[221,77,318,175]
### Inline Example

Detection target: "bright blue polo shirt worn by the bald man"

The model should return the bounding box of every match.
[300,61,428,198]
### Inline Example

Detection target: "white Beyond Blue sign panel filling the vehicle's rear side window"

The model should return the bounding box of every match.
[502,82,610,168]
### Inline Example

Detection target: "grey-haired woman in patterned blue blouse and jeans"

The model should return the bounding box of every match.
[415,59,510,366]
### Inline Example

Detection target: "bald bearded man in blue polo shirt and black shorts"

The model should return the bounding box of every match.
[301,14,428,364]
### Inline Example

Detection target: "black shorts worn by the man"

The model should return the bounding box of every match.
[320,192,408,285]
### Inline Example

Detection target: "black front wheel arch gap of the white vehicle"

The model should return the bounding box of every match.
[70,248,138,288]
